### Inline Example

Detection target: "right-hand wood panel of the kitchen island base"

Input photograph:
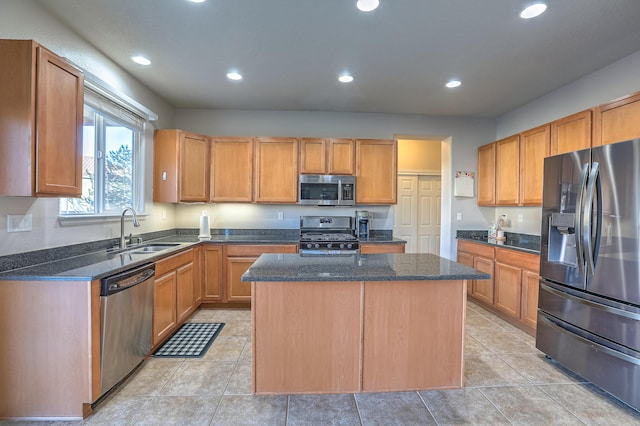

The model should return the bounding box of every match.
[362,281,466,392]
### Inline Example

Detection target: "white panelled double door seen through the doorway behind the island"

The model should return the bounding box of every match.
[393,175,442,255]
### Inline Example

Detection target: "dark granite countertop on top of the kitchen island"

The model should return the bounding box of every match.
[242,253,491,281]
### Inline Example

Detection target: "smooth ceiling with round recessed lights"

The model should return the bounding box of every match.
[39,0,640,117]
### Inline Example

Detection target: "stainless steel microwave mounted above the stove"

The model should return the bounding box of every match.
[298,175,356,206]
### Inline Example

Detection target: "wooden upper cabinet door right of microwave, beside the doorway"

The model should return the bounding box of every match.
[356,139,398,204]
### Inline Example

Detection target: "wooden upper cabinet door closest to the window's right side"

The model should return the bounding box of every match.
[179,132,209,202]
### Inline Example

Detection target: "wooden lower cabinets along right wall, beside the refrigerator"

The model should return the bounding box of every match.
[458,240,540,332]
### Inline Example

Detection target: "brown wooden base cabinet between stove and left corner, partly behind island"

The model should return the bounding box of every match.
[223,244,298,303]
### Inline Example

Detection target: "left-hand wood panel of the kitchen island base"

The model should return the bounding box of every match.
[252,281,363,393]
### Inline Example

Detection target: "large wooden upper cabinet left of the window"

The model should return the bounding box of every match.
[0,40,84,197]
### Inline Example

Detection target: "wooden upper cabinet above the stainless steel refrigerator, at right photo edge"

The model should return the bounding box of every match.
[593,93,640,145]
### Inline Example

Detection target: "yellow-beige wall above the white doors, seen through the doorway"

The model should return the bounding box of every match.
[398,139,442,174]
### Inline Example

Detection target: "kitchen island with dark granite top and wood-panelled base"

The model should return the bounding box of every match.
[242,254,489,394]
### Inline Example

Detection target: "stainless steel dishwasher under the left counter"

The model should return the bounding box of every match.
[100,264,155,395]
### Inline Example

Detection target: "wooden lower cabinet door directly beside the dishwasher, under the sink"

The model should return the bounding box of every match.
[153,271,177,346]
